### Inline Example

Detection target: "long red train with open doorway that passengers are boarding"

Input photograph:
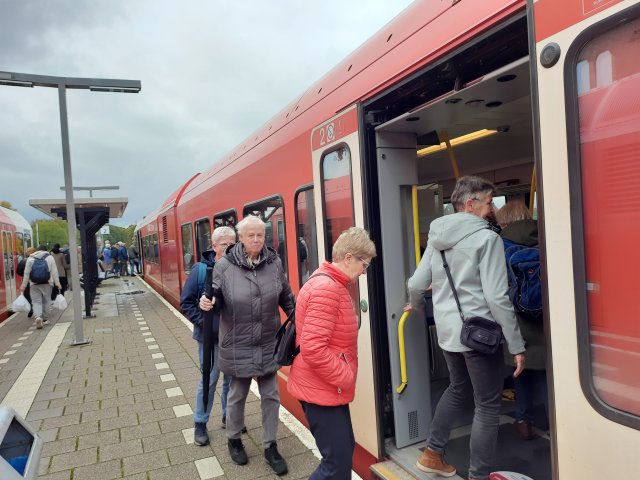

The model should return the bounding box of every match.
[138,0,640,479]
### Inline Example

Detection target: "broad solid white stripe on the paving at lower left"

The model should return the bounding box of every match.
[2,322,71,417]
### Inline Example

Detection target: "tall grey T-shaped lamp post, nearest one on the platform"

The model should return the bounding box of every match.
[0,72,142,345]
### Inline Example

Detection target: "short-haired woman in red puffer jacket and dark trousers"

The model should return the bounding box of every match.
[287,227,376,480]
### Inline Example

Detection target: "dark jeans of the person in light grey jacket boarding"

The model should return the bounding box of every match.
[427,348,504,480]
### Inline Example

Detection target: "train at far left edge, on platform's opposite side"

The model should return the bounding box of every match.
[0,207,33,322]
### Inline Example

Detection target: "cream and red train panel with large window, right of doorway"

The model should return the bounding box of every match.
[529,0,640,478]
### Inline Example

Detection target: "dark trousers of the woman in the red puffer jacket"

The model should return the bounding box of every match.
[300,402,356,480]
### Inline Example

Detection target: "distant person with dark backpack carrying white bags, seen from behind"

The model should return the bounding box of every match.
[20,245,61,329]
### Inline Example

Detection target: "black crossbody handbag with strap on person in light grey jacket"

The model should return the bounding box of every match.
[440,251,502,355]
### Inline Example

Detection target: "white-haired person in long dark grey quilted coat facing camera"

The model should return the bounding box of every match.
[200,215,295,475]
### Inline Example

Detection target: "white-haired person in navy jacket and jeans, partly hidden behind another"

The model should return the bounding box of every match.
[180,227,236,446]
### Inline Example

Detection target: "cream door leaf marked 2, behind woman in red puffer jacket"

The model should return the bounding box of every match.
[311,106,380,462]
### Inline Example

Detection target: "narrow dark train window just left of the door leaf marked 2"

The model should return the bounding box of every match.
[295,186,318,286]
